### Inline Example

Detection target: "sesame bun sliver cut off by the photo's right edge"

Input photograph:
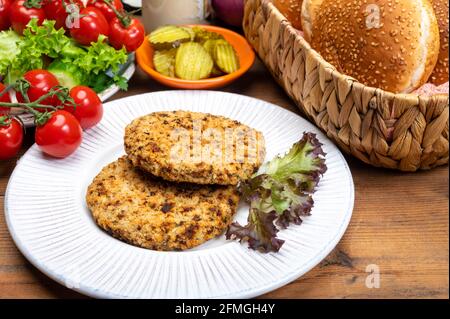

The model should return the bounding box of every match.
[430,0,448,85]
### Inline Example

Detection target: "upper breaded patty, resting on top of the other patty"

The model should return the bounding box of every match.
[125,111,265,185]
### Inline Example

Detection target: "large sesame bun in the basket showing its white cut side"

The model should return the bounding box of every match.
[310,0,439,93]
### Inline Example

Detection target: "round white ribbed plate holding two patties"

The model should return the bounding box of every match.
[5,91,354,298]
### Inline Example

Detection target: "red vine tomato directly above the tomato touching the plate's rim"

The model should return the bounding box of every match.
[64,85,103,130]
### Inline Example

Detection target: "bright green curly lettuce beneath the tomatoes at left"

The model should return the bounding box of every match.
[4,19,128,92]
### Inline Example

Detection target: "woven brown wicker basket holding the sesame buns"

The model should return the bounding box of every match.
[244,0,449,171]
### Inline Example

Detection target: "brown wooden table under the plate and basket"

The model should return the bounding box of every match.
[0,61,449,298]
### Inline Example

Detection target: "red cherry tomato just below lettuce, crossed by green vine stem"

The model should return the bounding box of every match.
[17,70,61,112]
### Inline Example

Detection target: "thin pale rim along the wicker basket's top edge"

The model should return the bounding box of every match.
[262,0,449,107]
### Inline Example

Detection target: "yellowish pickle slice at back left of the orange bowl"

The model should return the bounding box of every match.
[149,25,191,49]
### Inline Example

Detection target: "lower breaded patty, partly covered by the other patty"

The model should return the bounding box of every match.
[86,156,239,250]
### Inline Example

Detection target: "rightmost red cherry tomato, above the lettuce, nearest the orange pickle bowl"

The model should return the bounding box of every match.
[109,18,145,52]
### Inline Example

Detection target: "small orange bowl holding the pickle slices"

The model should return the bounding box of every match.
[136,25,255,90]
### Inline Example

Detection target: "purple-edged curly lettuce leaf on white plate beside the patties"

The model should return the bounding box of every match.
[226,133,327,252]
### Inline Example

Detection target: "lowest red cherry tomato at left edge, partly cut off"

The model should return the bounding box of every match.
[0,119,23,160]
